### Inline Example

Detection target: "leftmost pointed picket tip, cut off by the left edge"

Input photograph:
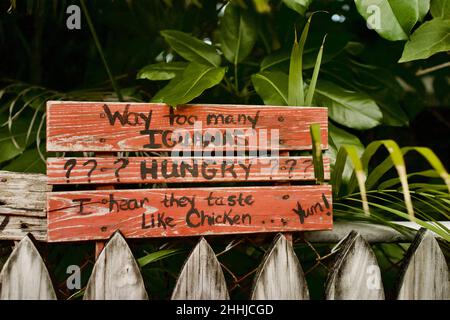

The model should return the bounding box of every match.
[0,235,56,300]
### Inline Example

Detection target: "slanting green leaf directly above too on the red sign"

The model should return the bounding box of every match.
[152,62,225,106]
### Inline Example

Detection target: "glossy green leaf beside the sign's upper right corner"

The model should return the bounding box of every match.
[315,81,383,130]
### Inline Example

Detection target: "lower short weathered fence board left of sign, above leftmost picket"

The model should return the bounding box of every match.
[0,214,47,241]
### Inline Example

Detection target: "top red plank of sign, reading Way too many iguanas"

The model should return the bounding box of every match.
[47,101,328,151]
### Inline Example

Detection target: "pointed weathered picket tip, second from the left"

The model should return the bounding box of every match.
[83,232,148,300]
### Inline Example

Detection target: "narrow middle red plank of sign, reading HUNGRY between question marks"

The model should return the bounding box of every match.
[47,157,330,184]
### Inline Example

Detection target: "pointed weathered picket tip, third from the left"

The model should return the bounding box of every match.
[172,237,230,300]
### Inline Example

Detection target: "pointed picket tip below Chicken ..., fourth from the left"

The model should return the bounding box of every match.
[251,234,309,300]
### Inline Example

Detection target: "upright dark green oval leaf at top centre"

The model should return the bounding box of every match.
[220,4,257,65]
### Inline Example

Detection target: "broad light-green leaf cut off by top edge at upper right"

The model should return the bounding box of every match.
[355,0,429,41]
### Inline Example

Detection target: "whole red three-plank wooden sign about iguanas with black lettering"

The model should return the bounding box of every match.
[47,102,332,241]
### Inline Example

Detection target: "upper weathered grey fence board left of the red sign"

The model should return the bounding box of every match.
[0,171,52,217]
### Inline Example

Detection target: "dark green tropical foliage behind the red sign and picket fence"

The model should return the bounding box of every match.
[0,0,450,297]
